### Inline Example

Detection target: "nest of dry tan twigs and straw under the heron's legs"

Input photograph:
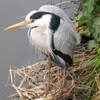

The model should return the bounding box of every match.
[10,44,97,100]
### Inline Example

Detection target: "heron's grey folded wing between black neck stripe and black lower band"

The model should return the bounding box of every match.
[54,20,77,58]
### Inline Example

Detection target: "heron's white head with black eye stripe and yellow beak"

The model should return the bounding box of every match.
[4,10,51,30]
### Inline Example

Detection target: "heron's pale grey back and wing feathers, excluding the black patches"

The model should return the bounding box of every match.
[39,5,78,68]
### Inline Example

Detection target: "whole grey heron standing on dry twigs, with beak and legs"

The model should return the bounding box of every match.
[4,5,78,96]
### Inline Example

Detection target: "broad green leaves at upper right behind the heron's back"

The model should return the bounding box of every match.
[74,0,100,50]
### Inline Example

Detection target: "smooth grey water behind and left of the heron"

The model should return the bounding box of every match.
[0,0,76,100]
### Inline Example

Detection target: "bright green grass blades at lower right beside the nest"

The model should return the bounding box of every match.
[86,48,100,100]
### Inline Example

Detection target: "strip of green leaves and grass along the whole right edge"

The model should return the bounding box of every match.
[73,0,100,100]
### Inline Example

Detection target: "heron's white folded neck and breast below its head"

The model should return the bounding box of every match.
[28,28,52,54]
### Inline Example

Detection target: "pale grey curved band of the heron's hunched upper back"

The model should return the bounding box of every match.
[38,5,78,40]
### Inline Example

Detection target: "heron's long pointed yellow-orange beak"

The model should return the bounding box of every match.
[4,21,30,31]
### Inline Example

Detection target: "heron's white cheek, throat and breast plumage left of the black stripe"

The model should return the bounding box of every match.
[28,14,53,55]
